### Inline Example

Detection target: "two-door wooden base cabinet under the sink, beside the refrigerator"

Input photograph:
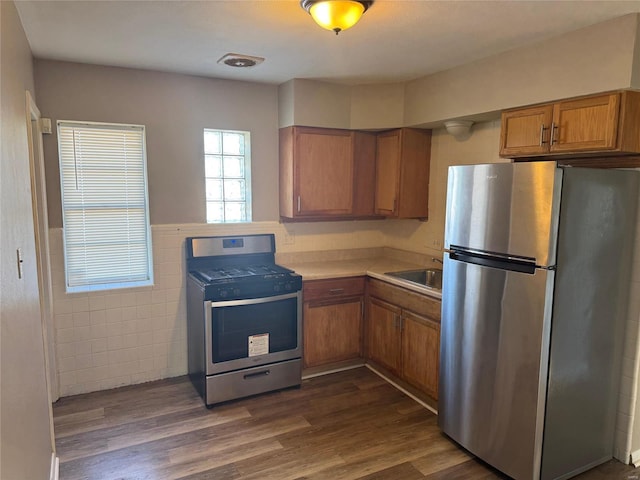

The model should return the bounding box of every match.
[365,279,441,399]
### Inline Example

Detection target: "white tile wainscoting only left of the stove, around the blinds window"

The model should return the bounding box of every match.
[50,229,187,396]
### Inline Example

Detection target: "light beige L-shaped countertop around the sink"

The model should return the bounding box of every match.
[279,257,442,299]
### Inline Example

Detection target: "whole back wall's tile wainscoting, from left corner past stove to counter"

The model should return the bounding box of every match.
[49,222,396,397]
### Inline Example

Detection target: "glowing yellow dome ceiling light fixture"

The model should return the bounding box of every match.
[300,0,373,35]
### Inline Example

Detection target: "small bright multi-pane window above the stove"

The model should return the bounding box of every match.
[204,128,251,223]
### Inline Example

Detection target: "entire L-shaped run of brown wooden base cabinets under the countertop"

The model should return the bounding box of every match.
[302,277,440,399]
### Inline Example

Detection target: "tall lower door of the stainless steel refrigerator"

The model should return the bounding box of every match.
[438,254,553,479]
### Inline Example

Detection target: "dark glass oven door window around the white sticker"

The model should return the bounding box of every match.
[211,298,298,363]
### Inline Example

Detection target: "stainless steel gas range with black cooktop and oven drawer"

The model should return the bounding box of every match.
[186,234,302,407]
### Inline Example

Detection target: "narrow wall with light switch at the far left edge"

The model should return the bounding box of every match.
[0,1,53,480]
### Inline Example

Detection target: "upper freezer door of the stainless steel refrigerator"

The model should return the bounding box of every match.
[445,162,562,266]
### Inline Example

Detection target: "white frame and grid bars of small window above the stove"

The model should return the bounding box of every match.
[202,127,253,225]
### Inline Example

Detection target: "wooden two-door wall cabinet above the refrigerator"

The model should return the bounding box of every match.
[500,91,640,158]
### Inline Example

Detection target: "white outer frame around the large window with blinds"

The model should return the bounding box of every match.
[56,120,154,293]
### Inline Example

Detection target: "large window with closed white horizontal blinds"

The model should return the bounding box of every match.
[58,121,153,292]
